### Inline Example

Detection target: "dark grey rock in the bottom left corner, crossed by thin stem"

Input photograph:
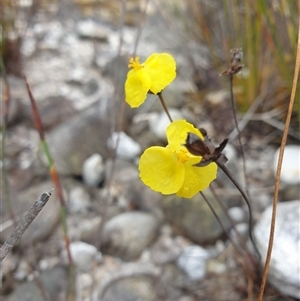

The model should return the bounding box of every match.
[5,267,68,301]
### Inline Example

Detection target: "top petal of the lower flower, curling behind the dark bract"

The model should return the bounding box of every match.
[166,119,203,152]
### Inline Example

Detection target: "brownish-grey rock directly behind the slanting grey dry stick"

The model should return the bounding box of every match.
[1,181,60,245]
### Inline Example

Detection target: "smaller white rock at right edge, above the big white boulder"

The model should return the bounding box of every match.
[273,145,300,184]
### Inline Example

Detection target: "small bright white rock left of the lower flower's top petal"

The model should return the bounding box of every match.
[107,132,142,160]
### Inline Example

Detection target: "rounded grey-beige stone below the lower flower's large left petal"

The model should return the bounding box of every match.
[101,212,160,261]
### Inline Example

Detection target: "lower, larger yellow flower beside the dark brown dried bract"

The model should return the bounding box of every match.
[139,120,217,198]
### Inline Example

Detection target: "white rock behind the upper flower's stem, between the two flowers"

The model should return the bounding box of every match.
[148,108,184,141]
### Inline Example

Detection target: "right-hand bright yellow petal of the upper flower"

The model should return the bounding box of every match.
[144,53,176,94]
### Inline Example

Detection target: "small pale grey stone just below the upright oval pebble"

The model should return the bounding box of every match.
[67,186,91,213]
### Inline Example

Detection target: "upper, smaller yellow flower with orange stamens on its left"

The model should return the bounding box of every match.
[125,53,176,108]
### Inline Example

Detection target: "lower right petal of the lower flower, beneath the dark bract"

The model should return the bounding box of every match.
[177,163,217,198]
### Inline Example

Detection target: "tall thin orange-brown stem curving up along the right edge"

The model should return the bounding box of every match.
[257,18,300,301]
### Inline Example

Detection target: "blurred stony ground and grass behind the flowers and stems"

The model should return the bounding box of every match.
[0,0,300,301]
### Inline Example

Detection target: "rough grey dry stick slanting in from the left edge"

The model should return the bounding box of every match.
[0,189,53,262]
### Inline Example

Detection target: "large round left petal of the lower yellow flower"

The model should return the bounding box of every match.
[139,146,185,194]
